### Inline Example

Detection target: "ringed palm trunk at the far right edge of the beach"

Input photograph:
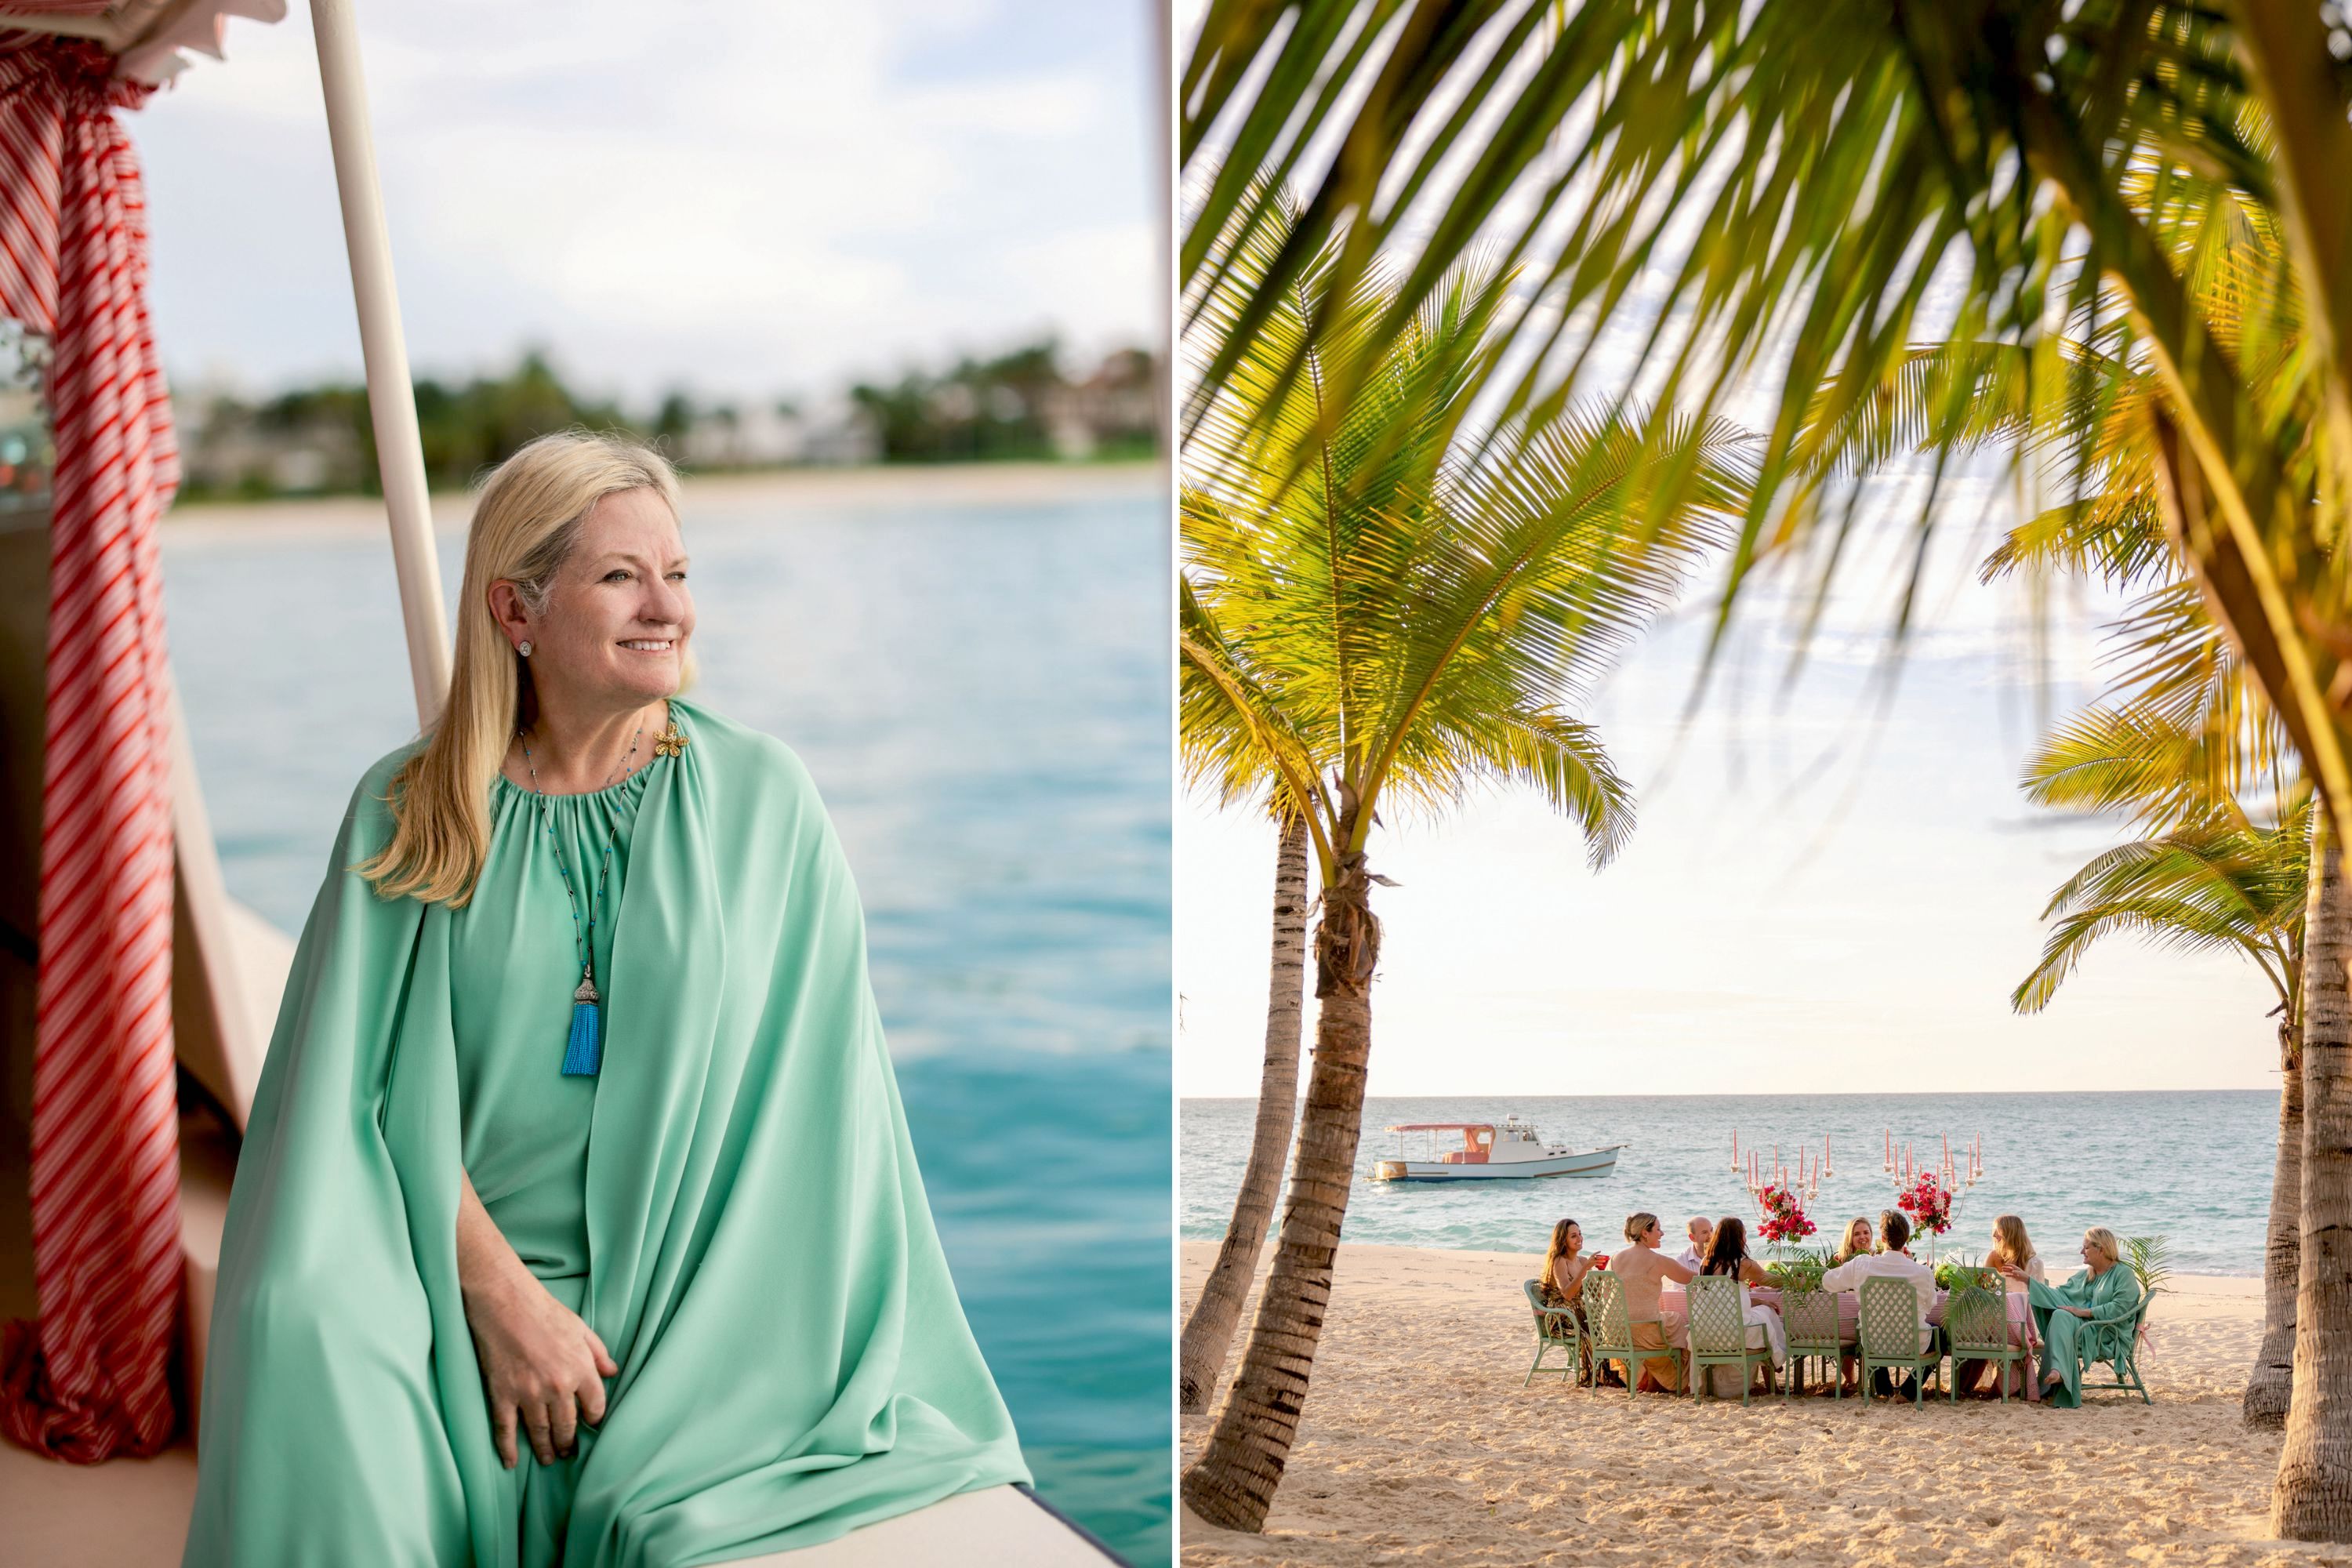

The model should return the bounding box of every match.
[2270,813,2352,1542]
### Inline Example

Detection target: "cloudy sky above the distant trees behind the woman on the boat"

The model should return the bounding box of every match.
[125,0,1162,402]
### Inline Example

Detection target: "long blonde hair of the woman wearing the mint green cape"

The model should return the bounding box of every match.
[350,428,694,907]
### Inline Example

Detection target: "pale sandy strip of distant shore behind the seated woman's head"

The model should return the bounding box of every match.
[160,461,1169,546]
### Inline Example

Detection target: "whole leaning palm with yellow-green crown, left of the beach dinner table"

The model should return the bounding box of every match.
[1178,199,1748,1530]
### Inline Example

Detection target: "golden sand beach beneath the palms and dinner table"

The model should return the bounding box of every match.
[1181,1241,2352,1568]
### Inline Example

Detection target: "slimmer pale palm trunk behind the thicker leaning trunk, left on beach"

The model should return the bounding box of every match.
[1176,813,1308,1415]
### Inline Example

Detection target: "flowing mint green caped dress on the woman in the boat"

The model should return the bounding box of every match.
[183,699,1030,1568]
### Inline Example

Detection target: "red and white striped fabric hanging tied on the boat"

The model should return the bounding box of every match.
[0,31,181,1462]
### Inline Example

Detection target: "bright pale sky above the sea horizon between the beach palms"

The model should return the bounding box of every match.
[1176,494,2277,1095]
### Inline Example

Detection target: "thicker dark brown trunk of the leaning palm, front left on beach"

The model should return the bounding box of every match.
[1183,846,1381,1533]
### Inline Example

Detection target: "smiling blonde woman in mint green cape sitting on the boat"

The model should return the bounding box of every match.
[183,433,1028,1568]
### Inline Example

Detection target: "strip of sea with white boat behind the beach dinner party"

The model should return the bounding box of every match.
[1181,1091,2279,1274]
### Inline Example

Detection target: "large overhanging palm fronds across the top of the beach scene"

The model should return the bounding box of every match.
[1181,0,2352,846]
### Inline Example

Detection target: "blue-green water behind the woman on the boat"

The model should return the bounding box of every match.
[165,480,1174,1563]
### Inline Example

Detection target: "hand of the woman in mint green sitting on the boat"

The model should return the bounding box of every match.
[466,1269,621,1469]
